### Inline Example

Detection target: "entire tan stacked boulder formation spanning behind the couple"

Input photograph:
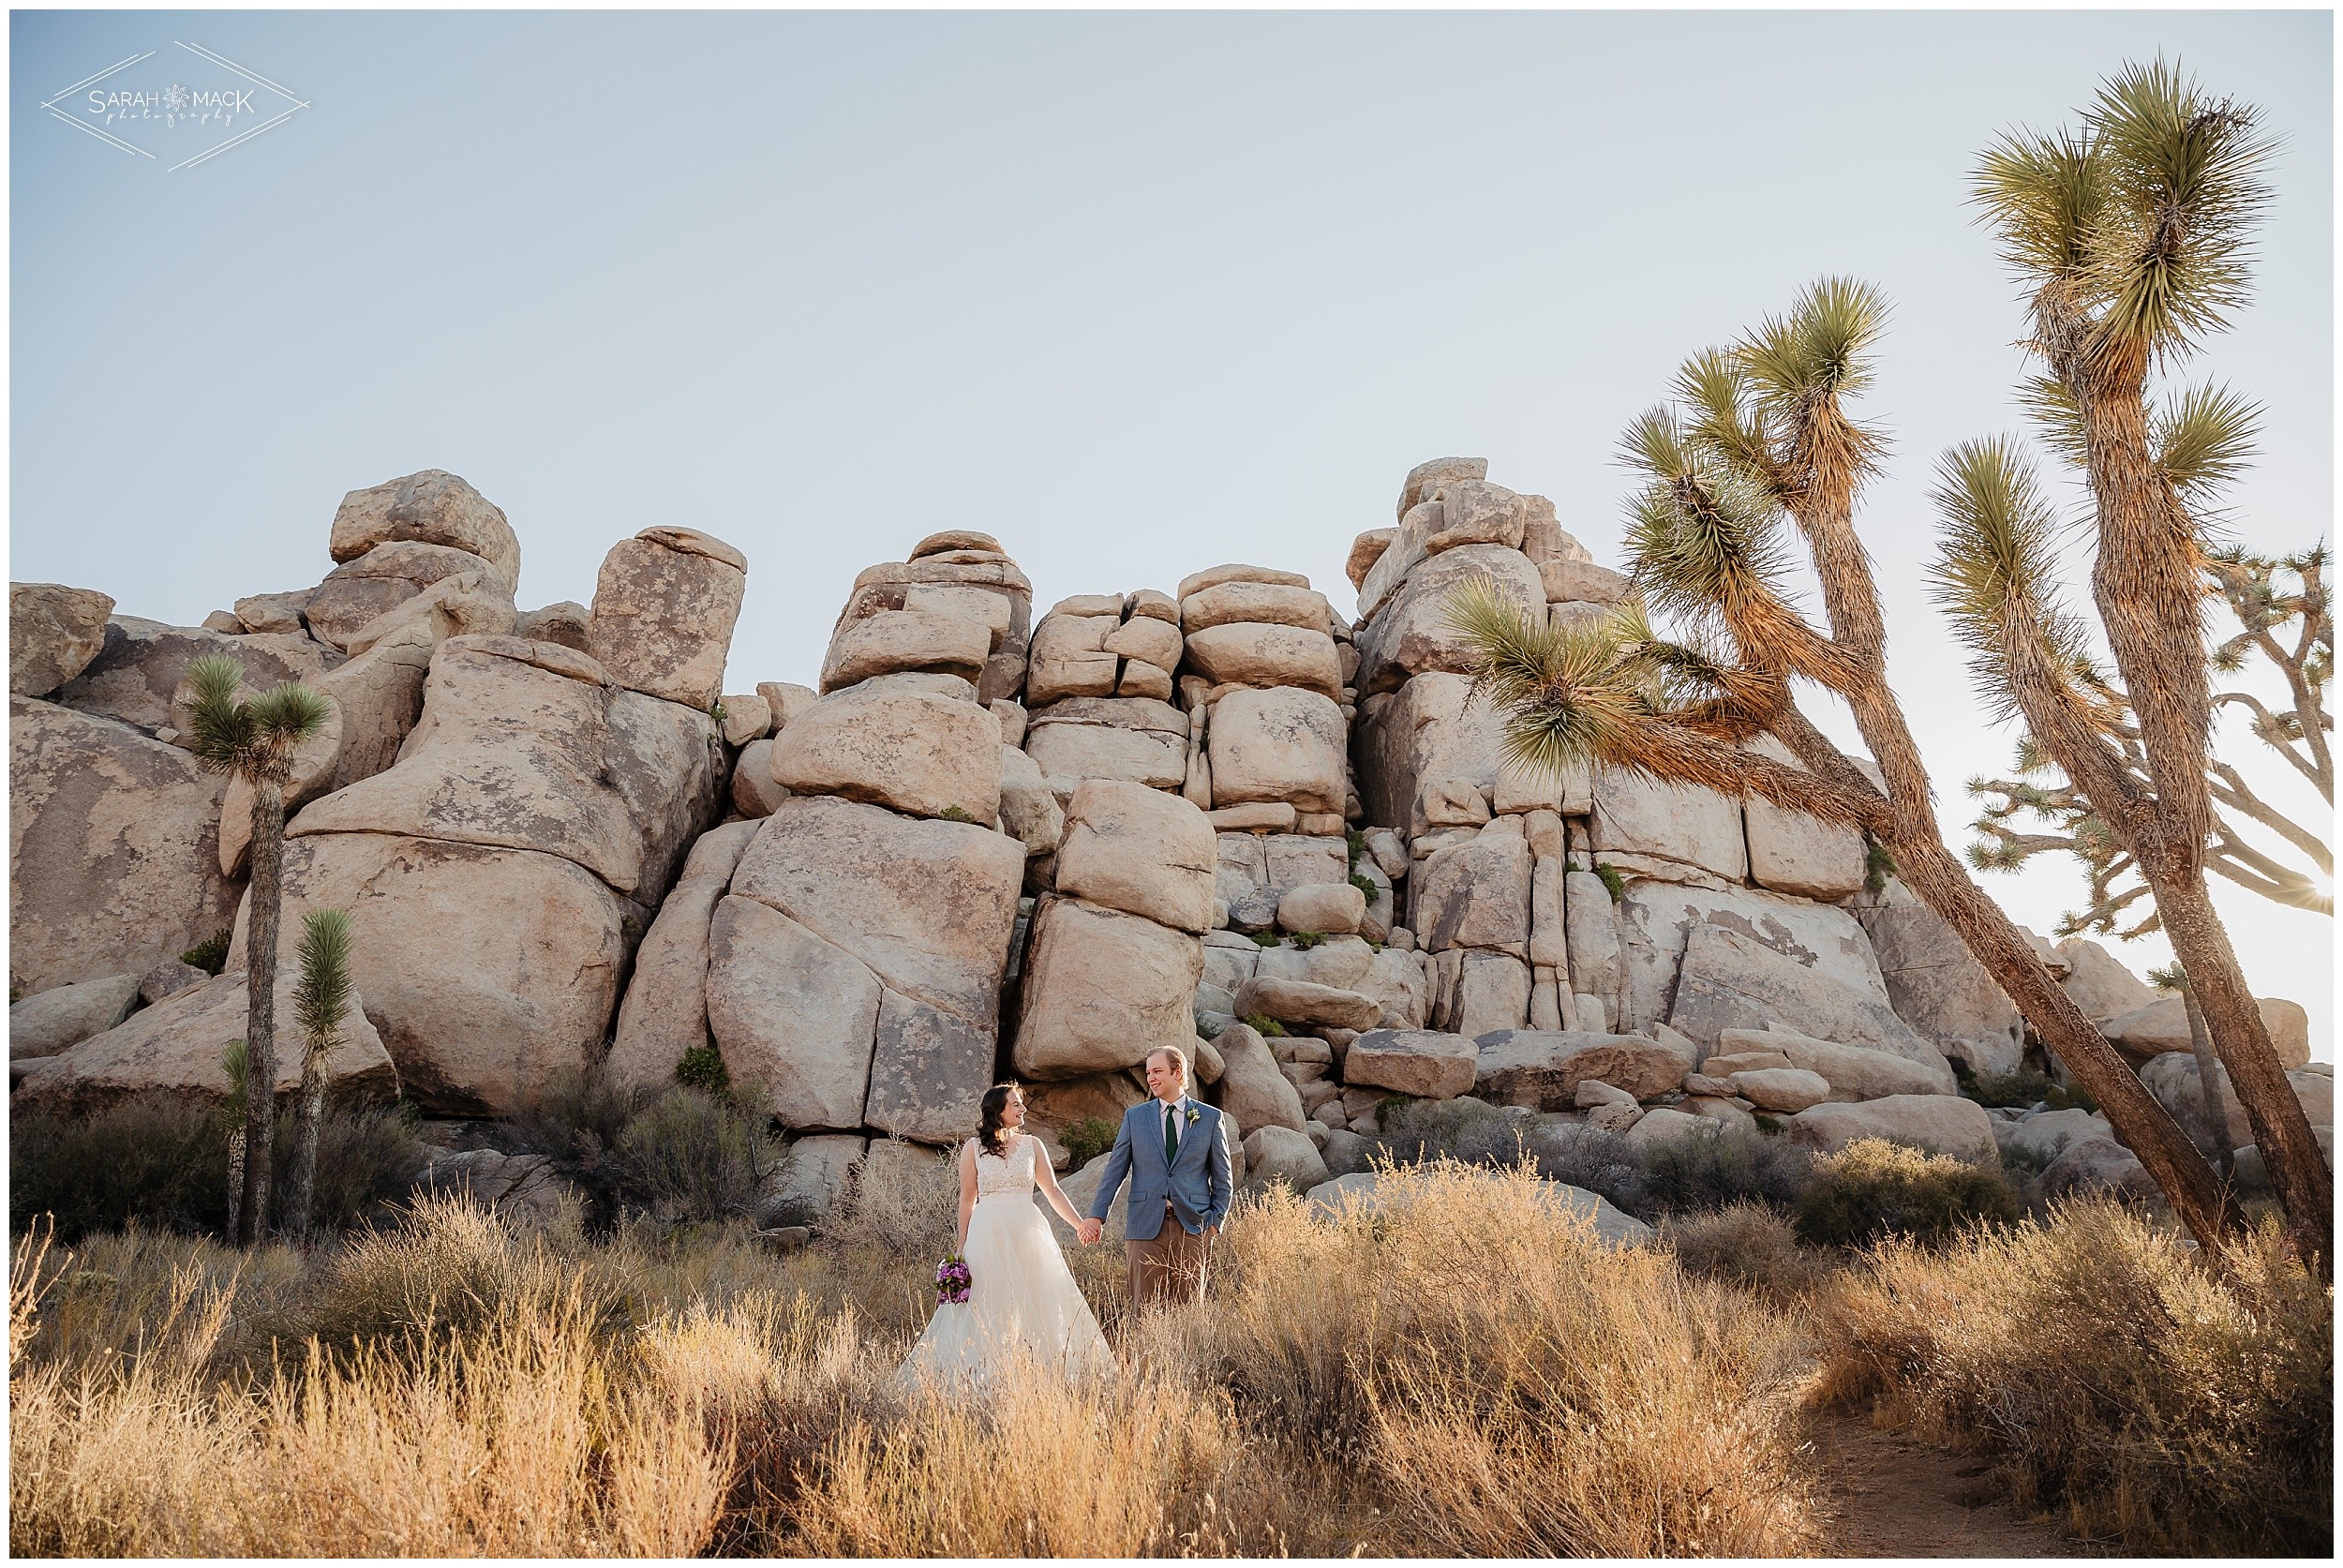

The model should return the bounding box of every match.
[9,459,2332,1223]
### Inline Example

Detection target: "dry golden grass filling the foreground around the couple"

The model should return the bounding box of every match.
[9,1165,2324,1556]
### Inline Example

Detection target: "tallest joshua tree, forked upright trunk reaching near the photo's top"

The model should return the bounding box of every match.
[1940,61,2334,1268]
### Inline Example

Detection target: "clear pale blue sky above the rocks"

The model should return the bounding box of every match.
[9,12,2334,1059]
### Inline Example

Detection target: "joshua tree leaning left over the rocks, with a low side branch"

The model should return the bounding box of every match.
[1451,279,2235,1251]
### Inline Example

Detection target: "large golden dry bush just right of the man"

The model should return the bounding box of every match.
[1162,1160,1812,1556]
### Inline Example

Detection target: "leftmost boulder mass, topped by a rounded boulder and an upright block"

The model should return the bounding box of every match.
[9,471,748,1115]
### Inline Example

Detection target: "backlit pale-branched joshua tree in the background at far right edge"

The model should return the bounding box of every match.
[1968,546,2336,940]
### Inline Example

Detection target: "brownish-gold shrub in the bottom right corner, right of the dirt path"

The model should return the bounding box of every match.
[1821,1200,2334,1559]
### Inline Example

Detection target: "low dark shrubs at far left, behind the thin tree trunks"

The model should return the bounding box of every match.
[9,1095,429,1242]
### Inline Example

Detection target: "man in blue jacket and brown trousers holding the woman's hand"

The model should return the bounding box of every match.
[1076,1045,1235,1307]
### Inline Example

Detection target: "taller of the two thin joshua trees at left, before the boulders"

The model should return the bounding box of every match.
[187,654,328,1247]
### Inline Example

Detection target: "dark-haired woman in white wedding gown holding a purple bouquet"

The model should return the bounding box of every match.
[898,1083,1115,1381]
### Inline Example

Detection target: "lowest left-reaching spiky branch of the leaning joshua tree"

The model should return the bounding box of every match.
[1443,576,1879,825]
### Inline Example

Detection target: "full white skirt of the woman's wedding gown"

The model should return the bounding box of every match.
[898,1195,1120,1382]
